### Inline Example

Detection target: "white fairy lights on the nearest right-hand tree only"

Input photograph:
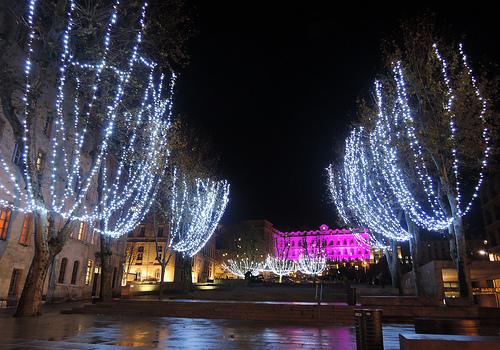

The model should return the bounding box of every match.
[373,45,490,227]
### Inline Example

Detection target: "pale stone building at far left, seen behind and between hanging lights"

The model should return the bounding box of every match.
[0,1,125,306]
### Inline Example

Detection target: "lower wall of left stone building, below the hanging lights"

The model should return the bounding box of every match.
[0,208,125,306]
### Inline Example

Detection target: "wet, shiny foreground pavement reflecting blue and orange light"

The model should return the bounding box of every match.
[0,303,414,350]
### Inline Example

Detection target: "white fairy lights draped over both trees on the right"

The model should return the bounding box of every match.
[327,45,490,240]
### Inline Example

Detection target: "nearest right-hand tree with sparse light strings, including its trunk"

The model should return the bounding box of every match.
[380,44,490,300]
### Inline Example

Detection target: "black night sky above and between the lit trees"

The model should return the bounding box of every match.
[174,0,500,231]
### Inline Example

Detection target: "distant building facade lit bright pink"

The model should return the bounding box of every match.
[275,225,370,261]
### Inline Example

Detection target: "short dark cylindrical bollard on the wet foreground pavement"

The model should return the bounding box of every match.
[354,309,384,350]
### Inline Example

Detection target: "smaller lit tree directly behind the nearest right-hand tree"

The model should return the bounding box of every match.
[327,128,410,295]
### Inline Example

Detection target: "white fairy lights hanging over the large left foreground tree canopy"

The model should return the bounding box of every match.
[0,0,175,236]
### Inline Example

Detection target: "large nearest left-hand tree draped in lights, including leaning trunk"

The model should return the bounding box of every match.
[0,0,170,316]
